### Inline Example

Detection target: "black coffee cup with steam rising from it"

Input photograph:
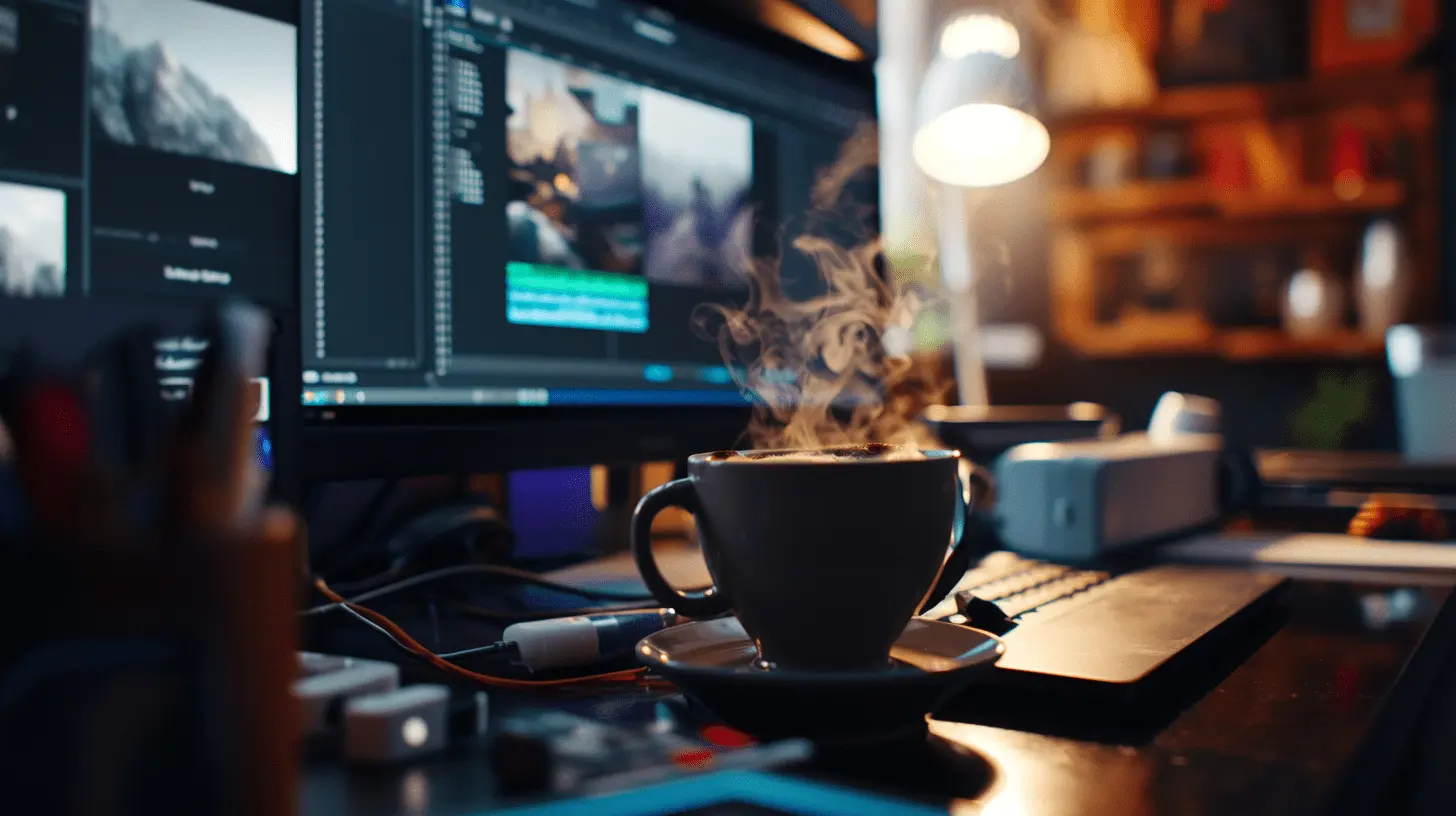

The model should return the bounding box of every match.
[632,446,964,670]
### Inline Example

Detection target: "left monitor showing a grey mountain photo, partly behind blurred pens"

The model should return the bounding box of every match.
[0,0,298,497]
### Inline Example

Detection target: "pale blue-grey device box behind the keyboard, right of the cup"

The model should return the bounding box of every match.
[996,433,1223,562]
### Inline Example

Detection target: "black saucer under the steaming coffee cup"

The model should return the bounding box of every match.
[638,618,1006,742]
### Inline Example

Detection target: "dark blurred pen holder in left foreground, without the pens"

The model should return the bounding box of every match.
[0,521,300,815]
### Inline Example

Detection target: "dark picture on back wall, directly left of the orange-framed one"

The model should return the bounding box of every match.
[1158,0,1319,87]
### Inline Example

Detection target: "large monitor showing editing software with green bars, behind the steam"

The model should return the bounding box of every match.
[300,0,874,479]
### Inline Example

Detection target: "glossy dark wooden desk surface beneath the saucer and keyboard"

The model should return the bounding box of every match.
[301,568,1456,816]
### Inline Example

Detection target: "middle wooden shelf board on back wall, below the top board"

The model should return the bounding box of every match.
[1051,181,1406,223]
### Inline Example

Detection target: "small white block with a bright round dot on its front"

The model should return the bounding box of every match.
[344,685,450,764]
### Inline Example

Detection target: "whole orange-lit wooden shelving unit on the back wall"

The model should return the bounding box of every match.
[1048,71,1440,361]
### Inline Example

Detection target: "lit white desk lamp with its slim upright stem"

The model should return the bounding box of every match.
[911,12,1051,405]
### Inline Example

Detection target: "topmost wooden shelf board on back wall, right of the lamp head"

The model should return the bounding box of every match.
[1047,71,1436,134]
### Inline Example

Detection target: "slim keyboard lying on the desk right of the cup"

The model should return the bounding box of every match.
[923,552,1287,697]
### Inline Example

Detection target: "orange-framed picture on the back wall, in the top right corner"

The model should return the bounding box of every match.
[1310,0,1437,74]
